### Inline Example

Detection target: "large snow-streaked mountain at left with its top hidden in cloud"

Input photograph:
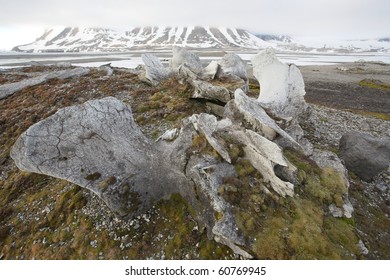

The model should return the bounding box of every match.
[13,26,276,52]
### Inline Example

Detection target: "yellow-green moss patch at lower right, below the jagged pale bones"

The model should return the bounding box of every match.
[241,149,358,259]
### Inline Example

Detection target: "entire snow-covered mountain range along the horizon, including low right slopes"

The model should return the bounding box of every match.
[13,26,390,53]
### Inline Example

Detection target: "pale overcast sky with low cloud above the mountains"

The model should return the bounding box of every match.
[0,0,390,49]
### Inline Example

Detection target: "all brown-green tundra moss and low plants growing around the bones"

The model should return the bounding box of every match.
[0,54,390,259]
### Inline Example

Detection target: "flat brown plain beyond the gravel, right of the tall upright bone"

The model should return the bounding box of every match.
[300,62,390,118]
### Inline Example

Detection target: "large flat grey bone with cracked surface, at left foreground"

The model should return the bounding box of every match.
[11,97,182,216]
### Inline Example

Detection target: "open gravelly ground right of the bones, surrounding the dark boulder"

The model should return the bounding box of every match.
[300,62,390,259]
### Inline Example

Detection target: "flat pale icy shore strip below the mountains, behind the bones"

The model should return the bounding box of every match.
[0,49,390,68]
